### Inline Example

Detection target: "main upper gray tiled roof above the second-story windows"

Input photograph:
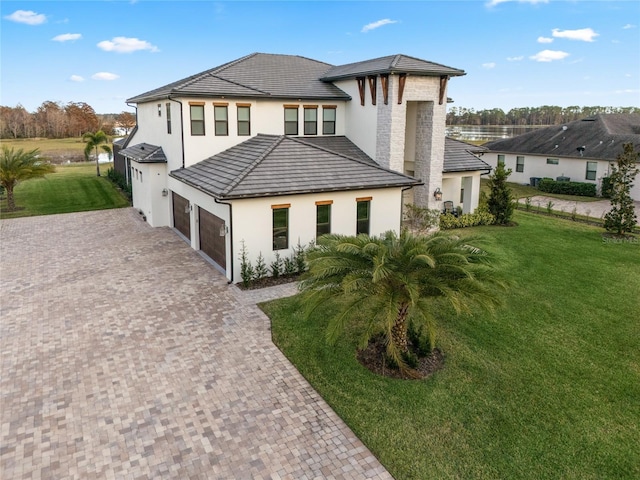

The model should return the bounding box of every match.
[127,53,351,103]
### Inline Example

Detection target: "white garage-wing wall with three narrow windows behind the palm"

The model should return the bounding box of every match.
[233,188,402,282]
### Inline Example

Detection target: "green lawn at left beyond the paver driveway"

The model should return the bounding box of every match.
[0,162,129,219]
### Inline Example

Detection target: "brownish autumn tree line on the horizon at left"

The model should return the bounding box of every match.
[0,101,136,139]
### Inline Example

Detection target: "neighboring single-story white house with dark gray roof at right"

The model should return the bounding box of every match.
[482,113,640,200]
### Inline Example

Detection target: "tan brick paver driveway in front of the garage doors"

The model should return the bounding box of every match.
[0,209,391,480]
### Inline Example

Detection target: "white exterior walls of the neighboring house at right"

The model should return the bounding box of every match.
[482,152,640,197]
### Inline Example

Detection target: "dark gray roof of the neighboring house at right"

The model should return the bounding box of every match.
[484,113,640,160]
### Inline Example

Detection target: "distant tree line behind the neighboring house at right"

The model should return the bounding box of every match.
[447,105,640,125]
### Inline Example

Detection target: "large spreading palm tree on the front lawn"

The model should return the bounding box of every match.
[301,231,504,376]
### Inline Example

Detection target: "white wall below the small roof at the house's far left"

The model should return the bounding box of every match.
[131,161,169,227]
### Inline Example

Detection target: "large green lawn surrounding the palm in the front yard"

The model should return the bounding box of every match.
[263,212,640,480]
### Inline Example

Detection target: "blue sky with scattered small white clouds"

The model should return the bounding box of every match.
[0,0,640,113]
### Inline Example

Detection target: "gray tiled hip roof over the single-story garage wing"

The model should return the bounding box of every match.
[169,134,421,199]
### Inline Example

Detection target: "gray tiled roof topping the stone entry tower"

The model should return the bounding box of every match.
[322,55,466,81]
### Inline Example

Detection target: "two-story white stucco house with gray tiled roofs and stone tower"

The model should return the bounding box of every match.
[114,53,489,282]
